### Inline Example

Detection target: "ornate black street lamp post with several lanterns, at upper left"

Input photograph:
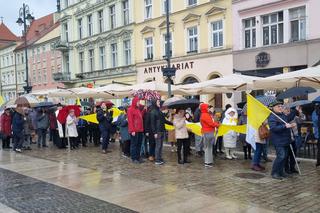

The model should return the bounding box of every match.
[17,3,34,93]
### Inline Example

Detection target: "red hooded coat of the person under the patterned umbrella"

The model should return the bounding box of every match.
[128,97,143,133]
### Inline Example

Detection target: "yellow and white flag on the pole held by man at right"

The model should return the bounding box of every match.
[246,94,271,149]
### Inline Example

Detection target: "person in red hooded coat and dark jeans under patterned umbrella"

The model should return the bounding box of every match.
[128,97,144,163]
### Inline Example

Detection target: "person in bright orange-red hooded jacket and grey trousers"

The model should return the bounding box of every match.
[200,104,219,167]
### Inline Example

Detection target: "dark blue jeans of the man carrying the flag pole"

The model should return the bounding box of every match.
[271,146,289,176]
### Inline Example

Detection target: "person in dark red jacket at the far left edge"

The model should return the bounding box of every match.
[1,109,12,149]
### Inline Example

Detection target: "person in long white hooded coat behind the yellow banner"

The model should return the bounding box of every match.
[222,108,238,160]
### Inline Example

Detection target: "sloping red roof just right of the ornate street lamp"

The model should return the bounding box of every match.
[16,13,55,50]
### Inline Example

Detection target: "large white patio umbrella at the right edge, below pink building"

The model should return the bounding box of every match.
[253,66,320,89]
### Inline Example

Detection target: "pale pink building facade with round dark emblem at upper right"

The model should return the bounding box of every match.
[232,0,320,77]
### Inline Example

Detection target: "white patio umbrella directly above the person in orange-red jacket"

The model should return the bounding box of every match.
[178,74,261,94]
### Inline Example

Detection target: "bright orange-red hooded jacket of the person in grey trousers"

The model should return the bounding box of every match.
[200,104,219,133]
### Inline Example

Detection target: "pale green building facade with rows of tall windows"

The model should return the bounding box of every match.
[53,0,136,87]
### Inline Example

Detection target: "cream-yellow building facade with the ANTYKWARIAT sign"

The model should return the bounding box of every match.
[134,0,233,108]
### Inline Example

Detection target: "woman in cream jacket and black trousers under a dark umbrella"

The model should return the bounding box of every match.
[173,109,191,164]
